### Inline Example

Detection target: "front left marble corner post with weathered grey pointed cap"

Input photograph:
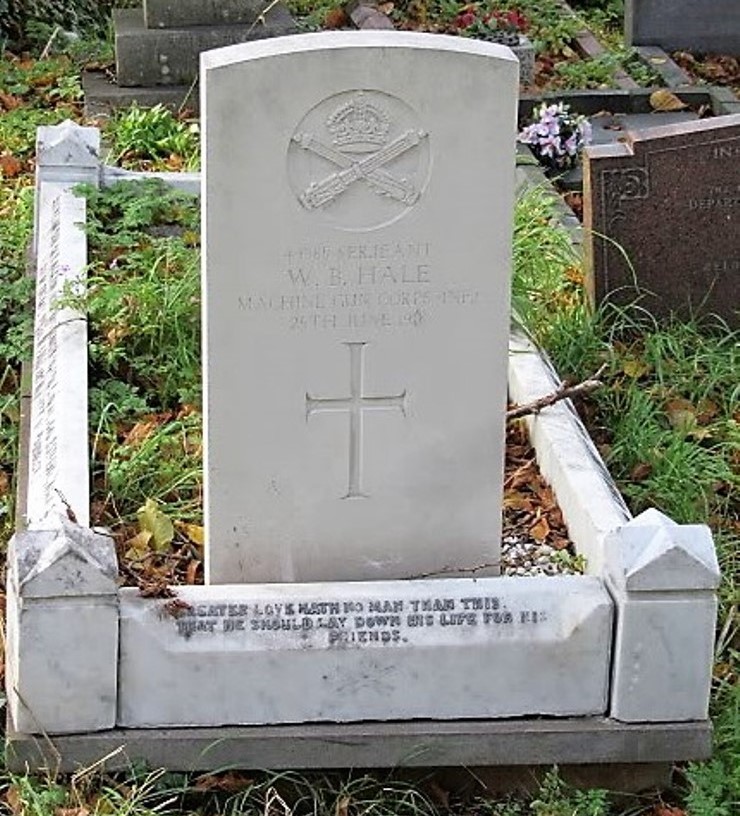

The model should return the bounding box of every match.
[5,520,118,734]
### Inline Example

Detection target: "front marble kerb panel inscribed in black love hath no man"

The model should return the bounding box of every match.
[119,576,612,727]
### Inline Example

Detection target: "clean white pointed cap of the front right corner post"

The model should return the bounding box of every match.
[607,509,720,592]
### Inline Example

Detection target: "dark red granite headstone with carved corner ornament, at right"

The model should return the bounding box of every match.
[584,114,740,327]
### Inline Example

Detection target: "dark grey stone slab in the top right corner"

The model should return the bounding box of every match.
[624,0,740,54]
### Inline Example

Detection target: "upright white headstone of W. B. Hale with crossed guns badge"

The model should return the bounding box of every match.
[202,32,517,583]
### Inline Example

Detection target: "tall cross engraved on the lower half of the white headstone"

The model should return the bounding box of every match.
[306,342,406,499]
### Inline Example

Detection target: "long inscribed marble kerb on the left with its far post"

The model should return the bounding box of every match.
[24,121,100,530]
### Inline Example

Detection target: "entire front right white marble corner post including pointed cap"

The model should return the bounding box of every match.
[605,509,720,722]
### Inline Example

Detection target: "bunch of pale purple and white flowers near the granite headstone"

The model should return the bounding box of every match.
[519,102,592,170]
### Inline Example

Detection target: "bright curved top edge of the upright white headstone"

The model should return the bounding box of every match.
[200,31,518,71]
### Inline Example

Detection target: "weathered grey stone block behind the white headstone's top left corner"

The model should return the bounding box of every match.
[113,4,296,87]
